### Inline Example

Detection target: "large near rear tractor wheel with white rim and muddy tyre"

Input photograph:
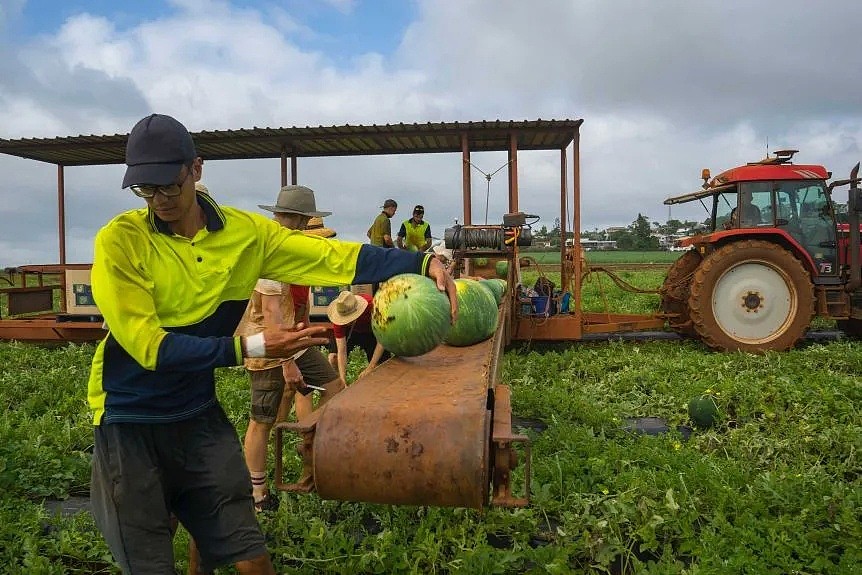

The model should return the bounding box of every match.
[688,240,814,353]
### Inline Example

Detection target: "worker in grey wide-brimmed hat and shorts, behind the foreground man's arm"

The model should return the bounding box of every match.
[237,186,344,511]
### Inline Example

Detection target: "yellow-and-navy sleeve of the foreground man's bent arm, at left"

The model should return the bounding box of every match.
[90,224,242,371]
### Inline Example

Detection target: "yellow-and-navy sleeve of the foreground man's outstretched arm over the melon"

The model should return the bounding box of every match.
[257,216,431,286]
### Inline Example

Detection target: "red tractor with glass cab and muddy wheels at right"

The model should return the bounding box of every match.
[661,150,862,353]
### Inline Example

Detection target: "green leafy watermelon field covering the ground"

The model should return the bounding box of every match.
[0,268,862,575]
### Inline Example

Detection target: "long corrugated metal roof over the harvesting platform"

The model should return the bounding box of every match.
[0,119,583,166]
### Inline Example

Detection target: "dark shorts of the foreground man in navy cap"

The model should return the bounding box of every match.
[90,405,266,574]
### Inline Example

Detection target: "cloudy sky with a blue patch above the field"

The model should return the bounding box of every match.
[0,0,862,266]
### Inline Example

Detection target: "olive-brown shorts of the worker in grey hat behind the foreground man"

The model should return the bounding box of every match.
[249,347,338,423]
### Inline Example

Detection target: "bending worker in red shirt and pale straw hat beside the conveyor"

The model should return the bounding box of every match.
[326,290,389,381]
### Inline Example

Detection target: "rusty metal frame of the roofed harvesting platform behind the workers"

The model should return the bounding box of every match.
[0,119,665,343]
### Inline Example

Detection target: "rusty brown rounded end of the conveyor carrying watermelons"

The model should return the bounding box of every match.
[314,347,491,508]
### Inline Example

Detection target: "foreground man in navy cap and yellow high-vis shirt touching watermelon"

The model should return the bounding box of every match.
[88,114,457,574]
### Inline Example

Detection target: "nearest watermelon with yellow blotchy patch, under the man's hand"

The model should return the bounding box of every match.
[371,274,451,357]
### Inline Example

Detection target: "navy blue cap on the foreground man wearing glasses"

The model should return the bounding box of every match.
[123,114,197,188]
